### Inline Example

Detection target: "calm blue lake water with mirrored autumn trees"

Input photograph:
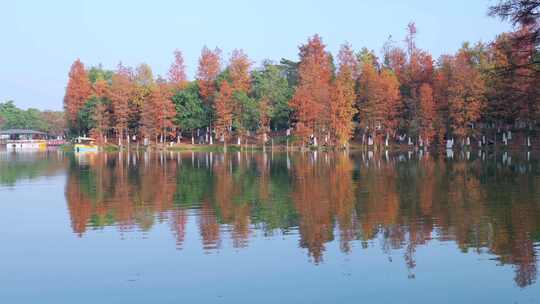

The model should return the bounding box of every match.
[0,151,540,303]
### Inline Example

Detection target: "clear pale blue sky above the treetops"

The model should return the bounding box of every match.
[0,0,510,110]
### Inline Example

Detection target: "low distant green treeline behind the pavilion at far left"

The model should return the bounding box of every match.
[0,101,66,135]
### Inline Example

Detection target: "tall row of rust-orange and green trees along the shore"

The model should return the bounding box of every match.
[64,1,540,147]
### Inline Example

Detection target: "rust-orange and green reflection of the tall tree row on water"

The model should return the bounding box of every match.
[66,152,540,287]
